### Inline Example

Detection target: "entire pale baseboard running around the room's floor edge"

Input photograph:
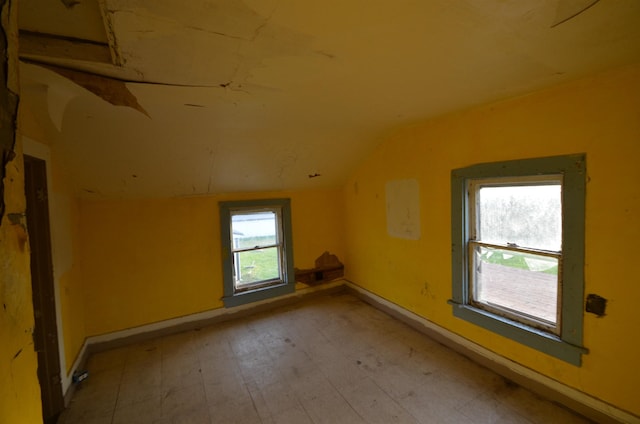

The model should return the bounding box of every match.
[64,280,640,424]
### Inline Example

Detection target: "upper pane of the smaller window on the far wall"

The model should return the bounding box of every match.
[231,211,277,250]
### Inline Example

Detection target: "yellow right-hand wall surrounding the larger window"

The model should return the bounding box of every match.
[344,66,640,415]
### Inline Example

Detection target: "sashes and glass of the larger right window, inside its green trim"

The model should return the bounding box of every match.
[468,176,562,334]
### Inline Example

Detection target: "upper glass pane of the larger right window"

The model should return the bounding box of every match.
[477,184,562,252]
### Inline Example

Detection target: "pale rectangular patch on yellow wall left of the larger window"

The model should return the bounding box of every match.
[385,179,420,240]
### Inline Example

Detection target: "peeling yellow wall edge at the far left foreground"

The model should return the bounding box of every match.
[0,0,42,423]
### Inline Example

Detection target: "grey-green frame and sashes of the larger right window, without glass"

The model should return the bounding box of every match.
[449,154,587,366]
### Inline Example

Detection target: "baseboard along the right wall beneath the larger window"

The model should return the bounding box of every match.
[345,281,640,424]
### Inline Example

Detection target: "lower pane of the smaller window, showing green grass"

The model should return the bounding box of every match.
[234,247,281,288]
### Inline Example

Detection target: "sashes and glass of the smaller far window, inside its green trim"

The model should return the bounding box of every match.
[230,208,284,292]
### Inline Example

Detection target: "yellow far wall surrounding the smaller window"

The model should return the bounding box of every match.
[80,190,344,335]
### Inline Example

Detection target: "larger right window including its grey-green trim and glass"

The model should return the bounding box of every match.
[451,155,586,365]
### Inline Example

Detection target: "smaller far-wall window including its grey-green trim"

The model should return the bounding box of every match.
[220,199,294,306]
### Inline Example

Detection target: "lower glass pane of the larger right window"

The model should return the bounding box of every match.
[473,246,558,325]
